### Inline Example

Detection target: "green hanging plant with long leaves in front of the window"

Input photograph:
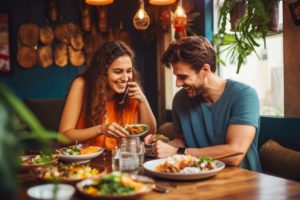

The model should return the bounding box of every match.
[213,0,279,73]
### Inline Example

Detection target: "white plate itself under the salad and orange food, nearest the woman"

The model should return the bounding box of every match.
[57,147,104,163]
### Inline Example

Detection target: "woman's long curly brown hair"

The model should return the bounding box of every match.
[81,41,140,126]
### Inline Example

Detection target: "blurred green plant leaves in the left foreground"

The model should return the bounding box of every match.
[0,84,66,199]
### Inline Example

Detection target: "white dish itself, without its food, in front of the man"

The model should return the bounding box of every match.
[143,159,225,180]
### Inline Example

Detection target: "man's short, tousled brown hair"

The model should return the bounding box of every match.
[161,36,216,72]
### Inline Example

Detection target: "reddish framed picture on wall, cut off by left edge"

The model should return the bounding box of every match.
[0,11,11,73]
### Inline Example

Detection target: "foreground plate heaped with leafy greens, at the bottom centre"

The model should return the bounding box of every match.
[76,171,154,199]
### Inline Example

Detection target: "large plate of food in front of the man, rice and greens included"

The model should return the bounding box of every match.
[143,155,225,180]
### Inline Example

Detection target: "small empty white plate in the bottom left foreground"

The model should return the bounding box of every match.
[27,184,75,200]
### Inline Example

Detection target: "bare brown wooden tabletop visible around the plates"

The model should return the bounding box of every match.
[17,151,300,200]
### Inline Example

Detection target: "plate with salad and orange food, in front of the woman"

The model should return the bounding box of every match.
[56,144,104,163]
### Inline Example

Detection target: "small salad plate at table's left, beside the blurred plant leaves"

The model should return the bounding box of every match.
[21,154,57,169]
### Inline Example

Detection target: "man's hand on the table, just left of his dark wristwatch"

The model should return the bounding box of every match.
[152,141,177,158]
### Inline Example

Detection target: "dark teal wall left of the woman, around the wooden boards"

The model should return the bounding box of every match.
[0,0,81,99]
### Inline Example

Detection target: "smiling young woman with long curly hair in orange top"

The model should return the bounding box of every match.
[59,42,156,149]
